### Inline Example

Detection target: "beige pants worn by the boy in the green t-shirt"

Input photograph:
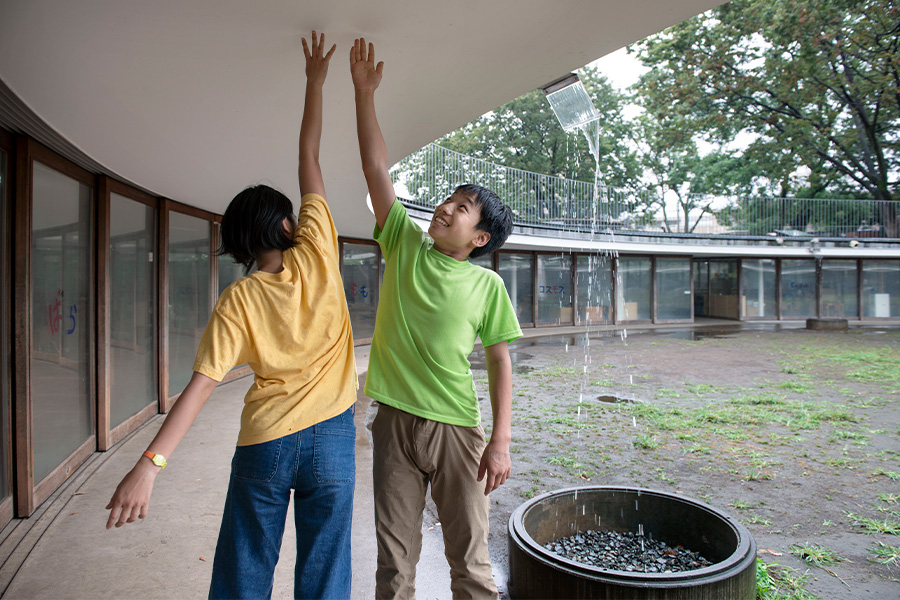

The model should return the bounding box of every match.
[372,404,497,600]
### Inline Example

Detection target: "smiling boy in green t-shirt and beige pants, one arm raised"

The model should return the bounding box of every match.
[350,38,522,598]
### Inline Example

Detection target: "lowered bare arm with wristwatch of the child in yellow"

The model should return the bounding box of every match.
[106,373,217,529]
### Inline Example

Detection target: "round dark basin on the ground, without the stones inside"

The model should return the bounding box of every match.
[509,486,756,600]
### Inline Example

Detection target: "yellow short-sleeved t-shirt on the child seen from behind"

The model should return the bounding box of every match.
[194,194,359,446]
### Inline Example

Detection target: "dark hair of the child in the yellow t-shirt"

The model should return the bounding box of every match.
[217,185,296,275]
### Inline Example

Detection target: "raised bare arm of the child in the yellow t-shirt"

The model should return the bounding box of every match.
[297,31,336,198]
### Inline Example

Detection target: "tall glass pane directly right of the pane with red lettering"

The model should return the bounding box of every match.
[109,194,157,428]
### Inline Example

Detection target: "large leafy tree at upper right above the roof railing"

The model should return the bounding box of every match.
[634,0,900,235]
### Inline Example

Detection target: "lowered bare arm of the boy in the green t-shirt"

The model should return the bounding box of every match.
[478,342,512,496]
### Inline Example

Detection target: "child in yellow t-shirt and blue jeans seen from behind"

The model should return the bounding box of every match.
[106,31,357,598]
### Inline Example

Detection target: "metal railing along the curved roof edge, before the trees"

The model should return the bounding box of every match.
[391,144,900,238]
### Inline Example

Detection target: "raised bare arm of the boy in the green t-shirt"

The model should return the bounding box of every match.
[350,38,394,228]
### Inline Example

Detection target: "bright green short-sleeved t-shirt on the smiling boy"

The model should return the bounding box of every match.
[365,201,522,427]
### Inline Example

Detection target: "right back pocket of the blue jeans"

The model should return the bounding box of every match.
[313,407,356,483]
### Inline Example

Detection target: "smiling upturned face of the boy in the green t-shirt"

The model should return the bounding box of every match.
[428,192,491,260]
